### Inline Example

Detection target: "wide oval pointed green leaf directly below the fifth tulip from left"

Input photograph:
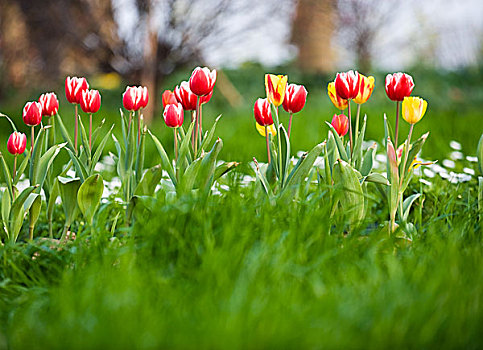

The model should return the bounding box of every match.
[77,174,104,226]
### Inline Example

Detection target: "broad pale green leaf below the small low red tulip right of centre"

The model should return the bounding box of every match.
[333,160,364,225]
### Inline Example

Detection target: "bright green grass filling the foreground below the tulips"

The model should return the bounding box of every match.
[0,174,483,349]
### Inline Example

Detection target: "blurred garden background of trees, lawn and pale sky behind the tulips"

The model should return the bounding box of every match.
[0,0,483,162]
